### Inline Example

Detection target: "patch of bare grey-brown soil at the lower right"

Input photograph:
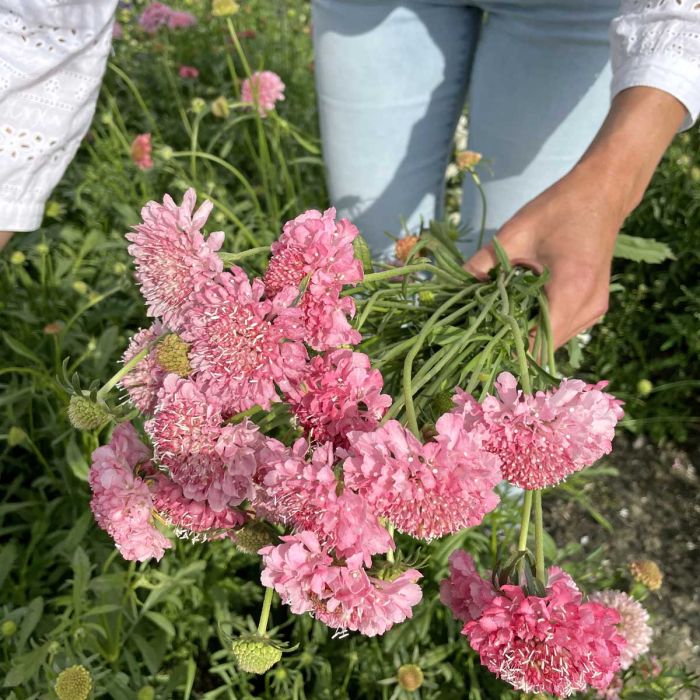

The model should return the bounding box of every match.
[545,435,700,673]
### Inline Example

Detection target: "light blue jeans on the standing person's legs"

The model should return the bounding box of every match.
[313,0,619,254]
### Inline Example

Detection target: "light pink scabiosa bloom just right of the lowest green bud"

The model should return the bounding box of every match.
[260,532,422,637]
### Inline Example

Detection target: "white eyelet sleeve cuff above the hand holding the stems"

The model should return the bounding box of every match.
[610,0,700,129]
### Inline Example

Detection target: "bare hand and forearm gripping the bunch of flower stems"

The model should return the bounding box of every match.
[465,87,687,347]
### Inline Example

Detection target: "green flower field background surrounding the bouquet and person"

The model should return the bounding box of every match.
[0,0,700,700]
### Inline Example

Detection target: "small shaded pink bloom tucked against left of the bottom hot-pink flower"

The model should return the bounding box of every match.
[440,549,498,622]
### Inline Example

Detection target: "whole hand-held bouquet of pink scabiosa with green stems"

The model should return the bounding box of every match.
[69,190,650,697]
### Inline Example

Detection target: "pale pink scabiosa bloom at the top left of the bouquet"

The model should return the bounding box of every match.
[126,188,224,332]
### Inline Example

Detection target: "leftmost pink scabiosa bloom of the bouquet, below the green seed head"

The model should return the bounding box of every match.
[89,423,172,561]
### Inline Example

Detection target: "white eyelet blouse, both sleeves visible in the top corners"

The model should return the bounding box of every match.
[0,0,700,231]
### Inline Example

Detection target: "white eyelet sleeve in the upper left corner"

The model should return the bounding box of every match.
[0,0,117,231]
